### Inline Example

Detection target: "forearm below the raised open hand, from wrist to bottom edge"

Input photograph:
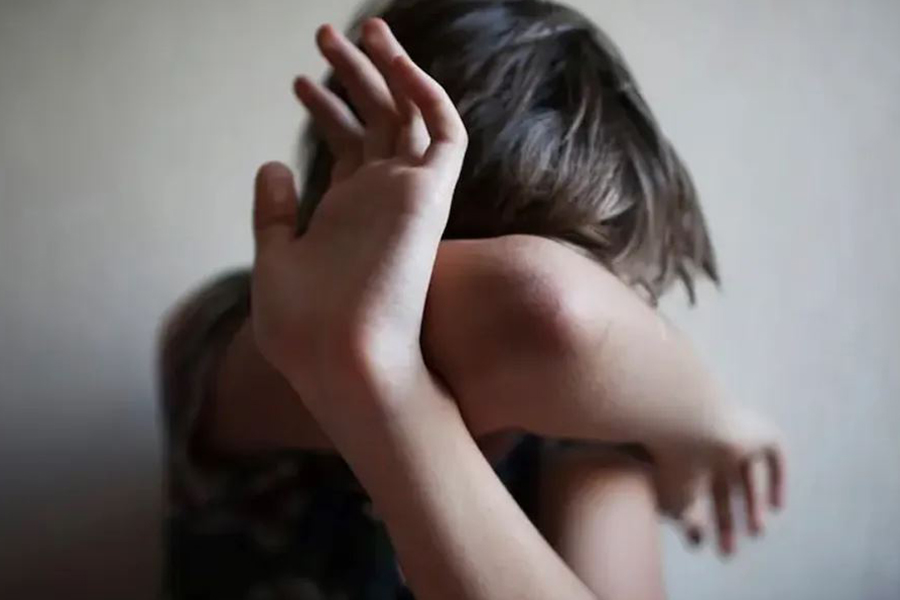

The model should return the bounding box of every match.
[340,386,594,600]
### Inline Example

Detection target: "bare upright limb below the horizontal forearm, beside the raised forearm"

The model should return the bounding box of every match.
[537,448,665,600]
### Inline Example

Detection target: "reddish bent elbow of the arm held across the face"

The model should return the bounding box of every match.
[423,235,614,394]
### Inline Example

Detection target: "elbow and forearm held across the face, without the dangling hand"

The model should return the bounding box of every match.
[424,236,723,446]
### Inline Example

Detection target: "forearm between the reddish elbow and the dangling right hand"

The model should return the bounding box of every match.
[472,284,723,445]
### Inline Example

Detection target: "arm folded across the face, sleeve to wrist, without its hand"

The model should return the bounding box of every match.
[206,236,717,454]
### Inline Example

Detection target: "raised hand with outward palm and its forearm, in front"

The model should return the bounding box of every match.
[252,17,596,600]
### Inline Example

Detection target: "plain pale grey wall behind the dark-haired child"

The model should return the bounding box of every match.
[0,0,900,600]
